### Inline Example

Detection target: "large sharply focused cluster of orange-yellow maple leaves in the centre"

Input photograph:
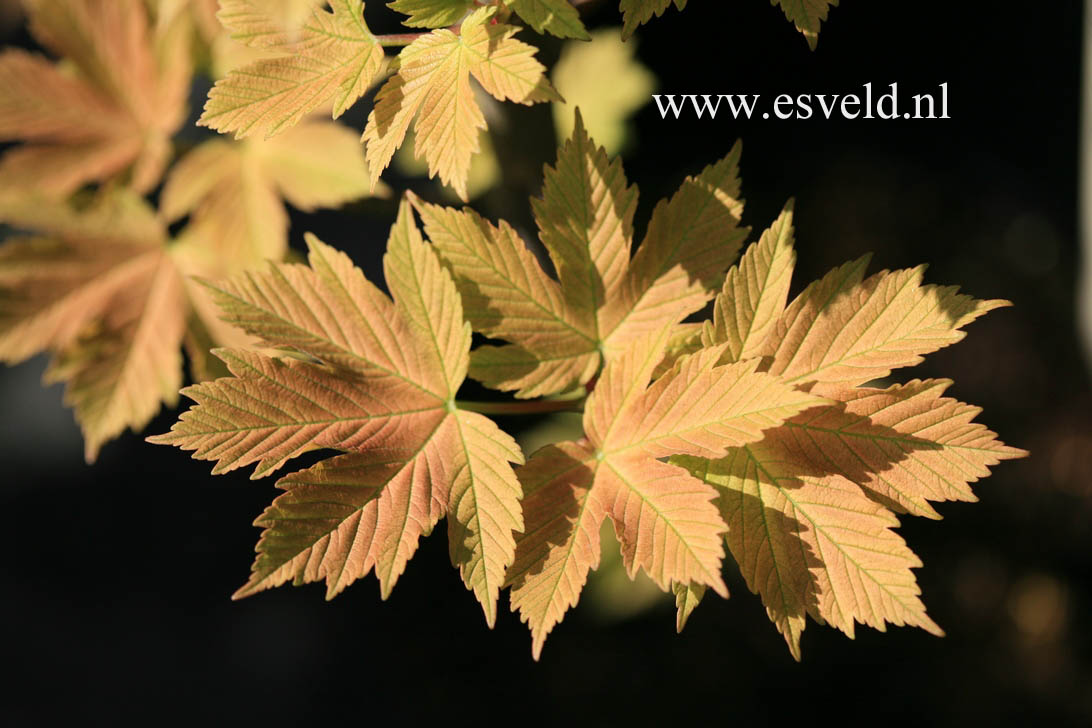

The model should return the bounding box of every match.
[152,115,1023,657]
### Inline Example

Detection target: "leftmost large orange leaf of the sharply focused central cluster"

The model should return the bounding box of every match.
[150,202,523,625]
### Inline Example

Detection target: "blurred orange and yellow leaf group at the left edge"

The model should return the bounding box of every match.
[0,0,370,461]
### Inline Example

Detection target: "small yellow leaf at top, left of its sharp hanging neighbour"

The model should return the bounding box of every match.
[198,0,383,139]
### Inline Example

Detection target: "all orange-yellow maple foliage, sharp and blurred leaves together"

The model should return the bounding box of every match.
[0,0,1024,658]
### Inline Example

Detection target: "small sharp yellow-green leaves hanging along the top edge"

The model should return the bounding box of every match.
[199,0,836,201]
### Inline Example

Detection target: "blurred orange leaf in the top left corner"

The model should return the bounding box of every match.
[0,0,191,199]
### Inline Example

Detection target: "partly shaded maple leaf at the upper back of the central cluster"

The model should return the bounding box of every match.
[415,109,747,397]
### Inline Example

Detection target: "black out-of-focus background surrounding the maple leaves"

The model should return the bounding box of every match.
[0,0,1092,725]
